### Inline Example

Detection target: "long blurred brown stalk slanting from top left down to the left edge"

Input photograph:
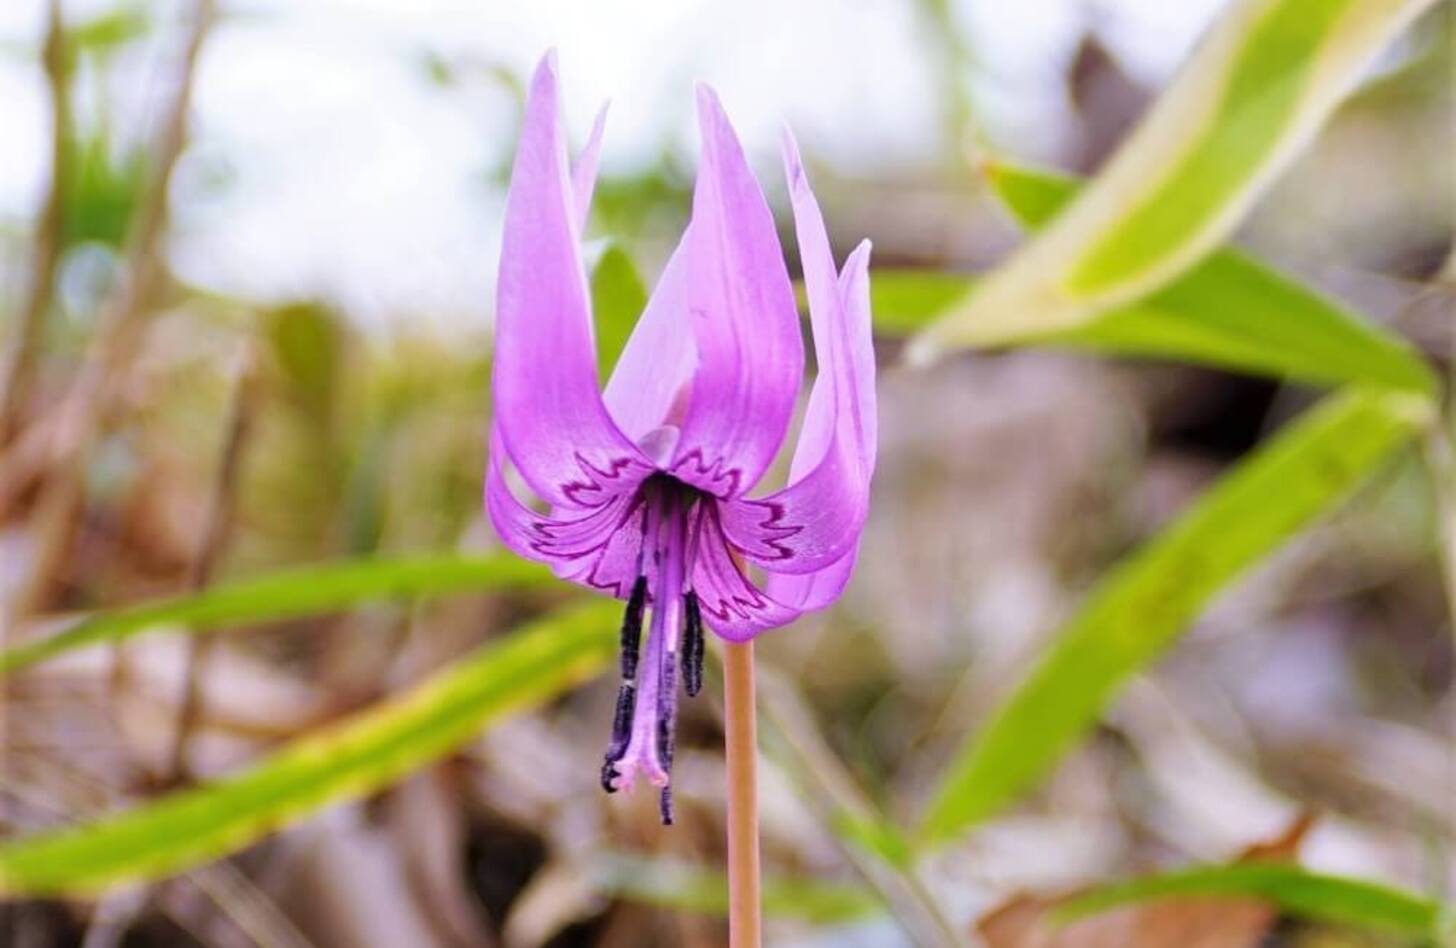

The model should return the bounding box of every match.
[10,0,215,620]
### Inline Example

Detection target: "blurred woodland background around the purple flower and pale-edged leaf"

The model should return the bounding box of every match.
[0,0,1456,948]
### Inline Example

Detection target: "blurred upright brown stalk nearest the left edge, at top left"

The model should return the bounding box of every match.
[0,0,71,446]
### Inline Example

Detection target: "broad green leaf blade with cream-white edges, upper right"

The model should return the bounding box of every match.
[913,0,1433,357]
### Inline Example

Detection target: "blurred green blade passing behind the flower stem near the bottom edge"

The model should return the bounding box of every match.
[588,853,884,925]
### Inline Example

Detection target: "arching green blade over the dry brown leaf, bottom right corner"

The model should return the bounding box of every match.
[1057,864,1441,936]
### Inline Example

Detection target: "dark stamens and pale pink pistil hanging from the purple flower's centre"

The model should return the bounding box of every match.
[601,473,708,824]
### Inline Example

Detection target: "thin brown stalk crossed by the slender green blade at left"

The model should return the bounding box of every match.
[167,349,258,782]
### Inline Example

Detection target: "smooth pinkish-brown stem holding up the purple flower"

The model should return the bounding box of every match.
[724,642,761,948]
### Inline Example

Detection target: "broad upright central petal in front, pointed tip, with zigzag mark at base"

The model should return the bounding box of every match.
[670,87,804,498]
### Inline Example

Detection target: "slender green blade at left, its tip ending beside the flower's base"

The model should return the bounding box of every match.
[0,553,556,676]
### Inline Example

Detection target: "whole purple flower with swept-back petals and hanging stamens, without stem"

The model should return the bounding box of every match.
[485,54,875,823]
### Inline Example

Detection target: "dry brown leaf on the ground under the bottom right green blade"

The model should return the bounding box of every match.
[977,813,1313,948]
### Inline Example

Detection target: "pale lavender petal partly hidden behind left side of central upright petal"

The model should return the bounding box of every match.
[601,236,697,443]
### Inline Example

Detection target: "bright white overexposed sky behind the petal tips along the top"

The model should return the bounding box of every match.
[0,0,1220,329]
